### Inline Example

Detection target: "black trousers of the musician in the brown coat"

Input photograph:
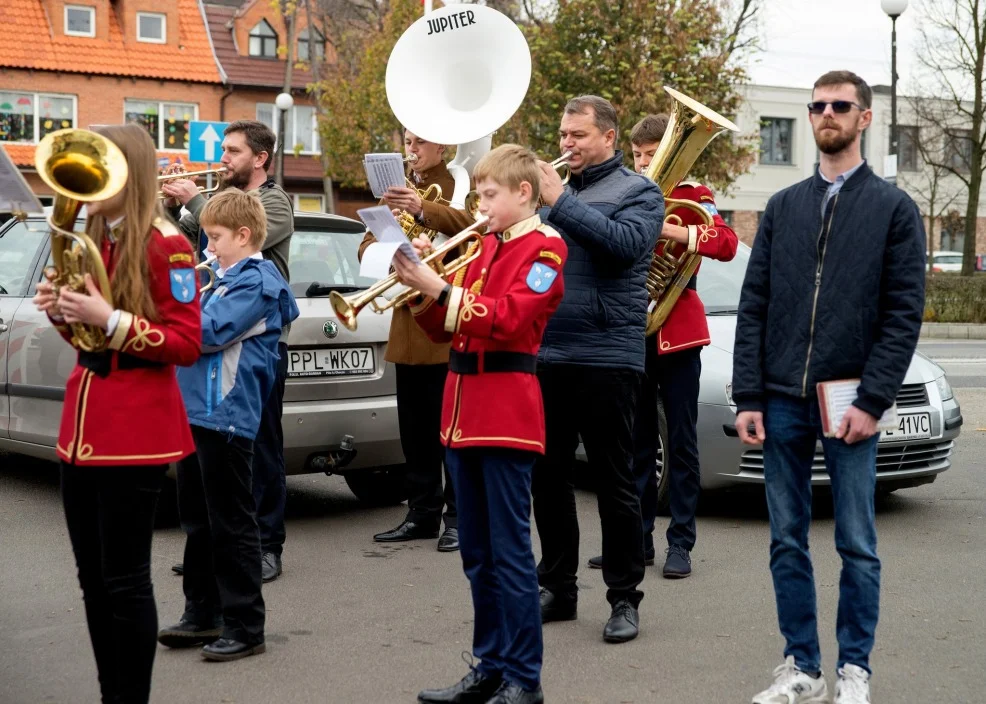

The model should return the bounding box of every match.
[394,364,458,528]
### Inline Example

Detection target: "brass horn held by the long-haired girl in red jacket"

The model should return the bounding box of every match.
[34,129,128,352]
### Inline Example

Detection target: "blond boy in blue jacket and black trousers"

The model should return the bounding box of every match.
[158,188,298,661]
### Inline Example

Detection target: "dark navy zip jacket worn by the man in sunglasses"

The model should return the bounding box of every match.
[733,164,926,417]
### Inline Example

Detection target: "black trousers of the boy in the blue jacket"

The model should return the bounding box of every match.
[178,425,264,644]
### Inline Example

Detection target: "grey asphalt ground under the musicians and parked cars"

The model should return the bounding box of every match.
[0,341,986,704]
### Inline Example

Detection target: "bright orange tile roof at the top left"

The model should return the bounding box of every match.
[0,0,222,83]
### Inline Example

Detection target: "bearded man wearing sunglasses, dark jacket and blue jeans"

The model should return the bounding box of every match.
[732,71,925,704]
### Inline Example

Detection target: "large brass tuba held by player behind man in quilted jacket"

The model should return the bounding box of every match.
[644,86,739,335]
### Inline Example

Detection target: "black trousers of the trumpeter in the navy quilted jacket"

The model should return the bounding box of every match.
[531,364,644,605]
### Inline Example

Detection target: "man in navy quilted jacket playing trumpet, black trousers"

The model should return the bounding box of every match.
[531,95,664,643]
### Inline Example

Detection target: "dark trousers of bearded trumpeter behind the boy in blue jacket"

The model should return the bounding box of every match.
[253,342,288,555]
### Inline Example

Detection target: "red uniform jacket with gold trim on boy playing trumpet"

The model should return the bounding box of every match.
[411,215,568,454]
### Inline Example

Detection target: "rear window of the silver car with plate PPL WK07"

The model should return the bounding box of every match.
[288,229,374,296]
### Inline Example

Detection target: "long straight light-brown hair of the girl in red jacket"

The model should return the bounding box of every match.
[86,125,164,321]
